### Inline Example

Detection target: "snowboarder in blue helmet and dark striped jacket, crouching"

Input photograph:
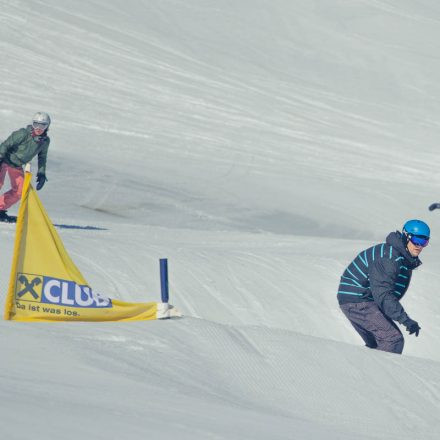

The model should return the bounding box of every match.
[337,220,431,354]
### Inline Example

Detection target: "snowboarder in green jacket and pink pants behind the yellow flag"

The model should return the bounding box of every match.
[0,112,50,222]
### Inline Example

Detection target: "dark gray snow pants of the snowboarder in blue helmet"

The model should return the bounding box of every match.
[340,302,405,354]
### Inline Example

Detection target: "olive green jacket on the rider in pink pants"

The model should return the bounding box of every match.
[0,125,50,174]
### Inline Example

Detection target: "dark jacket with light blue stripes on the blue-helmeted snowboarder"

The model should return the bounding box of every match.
[338,231,422,323]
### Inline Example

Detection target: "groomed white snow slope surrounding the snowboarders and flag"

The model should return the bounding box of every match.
[0,0,440,439]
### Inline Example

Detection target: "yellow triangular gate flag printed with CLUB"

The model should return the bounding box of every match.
[4,173,163,321]
